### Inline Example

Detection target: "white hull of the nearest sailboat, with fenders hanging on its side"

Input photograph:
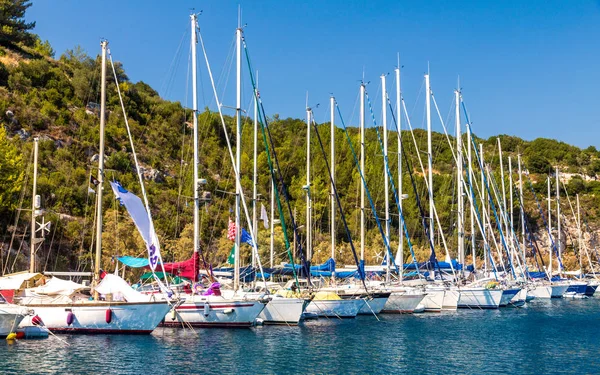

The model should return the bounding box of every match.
[21,301,170,334]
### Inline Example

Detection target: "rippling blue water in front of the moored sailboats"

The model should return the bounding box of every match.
[0,299,600,374]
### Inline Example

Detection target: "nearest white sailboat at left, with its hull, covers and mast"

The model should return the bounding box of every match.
[8,40,170,334]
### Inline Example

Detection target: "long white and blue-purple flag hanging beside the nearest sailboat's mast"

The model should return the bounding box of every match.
[110,181,162,271]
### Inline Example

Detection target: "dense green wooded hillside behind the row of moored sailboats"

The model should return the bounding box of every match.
[0,0,600,280]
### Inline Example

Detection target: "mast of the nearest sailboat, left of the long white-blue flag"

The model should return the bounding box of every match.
[94,40,108,300]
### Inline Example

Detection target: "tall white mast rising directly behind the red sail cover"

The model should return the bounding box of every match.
[190,14,200,253]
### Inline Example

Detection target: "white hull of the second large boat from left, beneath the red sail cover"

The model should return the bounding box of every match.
[163,295,265,328]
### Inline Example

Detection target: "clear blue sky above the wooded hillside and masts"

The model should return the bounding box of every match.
[27,0,600,148]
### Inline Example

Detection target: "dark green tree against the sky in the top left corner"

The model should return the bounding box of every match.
[0,0,35,46]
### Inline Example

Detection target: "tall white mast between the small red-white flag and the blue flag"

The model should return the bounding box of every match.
[233,17,242,291]
